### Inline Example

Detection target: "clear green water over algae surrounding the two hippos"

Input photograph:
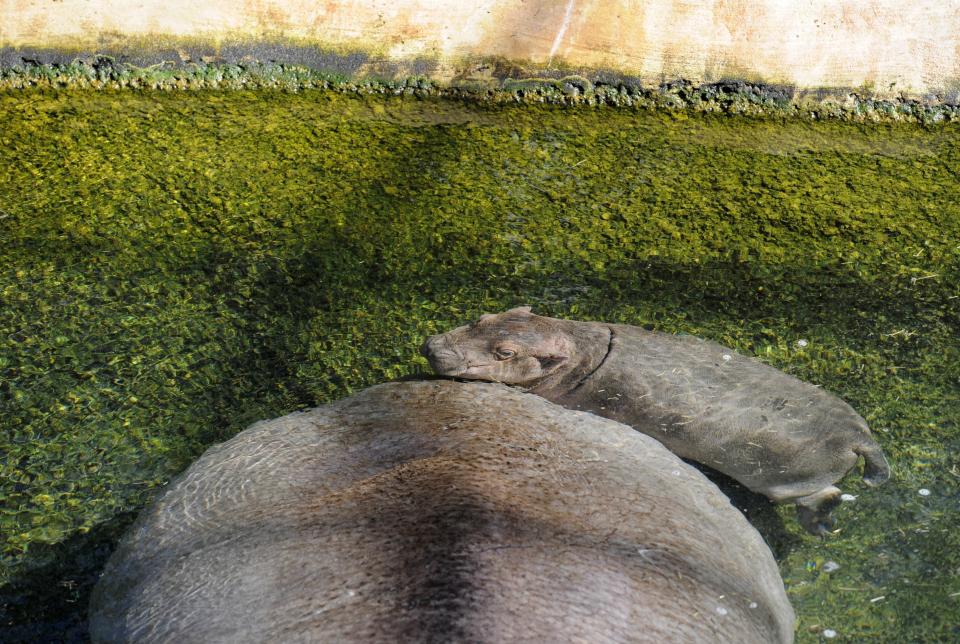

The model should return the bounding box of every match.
[0,91,960,642]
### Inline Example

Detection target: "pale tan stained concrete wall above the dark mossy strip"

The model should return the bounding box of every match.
[0,0,960,103]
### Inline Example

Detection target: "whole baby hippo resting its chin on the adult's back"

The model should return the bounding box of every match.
[421,307,890,534]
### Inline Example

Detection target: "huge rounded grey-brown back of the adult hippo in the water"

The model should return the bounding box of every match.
[90,380,794,644]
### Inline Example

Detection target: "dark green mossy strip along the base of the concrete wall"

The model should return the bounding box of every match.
[0,54,960,125]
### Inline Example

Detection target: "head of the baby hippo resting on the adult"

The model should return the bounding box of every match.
[420,306,575,385]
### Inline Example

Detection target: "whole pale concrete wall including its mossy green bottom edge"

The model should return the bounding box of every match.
[0,0,960,121]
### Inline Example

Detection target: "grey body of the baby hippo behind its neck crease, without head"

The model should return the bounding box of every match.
[552,325,889,501]
